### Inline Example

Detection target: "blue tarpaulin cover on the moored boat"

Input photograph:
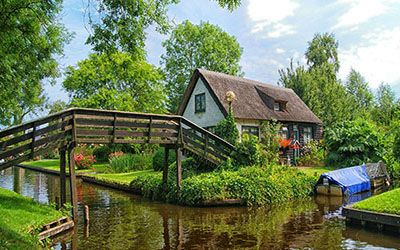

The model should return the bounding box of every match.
[319,164,371,195]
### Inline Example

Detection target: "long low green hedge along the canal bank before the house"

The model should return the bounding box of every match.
[179,166,316,205]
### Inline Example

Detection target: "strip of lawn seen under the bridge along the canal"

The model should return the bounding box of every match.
[89,170,161,185]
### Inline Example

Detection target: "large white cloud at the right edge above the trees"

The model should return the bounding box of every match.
[339,27,400,88]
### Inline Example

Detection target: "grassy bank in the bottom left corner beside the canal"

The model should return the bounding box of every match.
[0,188,62,249]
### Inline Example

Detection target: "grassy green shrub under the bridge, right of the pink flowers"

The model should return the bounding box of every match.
[109,154,152,173]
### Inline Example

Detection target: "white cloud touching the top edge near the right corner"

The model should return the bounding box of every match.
[333,0,388,29]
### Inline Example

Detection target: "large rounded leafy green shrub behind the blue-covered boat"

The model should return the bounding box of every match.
[325,119,384,167]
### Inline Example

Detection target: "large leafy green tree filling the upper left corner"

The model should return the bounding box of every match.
[0,0,70,126]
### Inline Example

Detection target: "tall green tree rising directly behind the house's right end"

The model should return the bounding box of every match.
[278,33,354,126]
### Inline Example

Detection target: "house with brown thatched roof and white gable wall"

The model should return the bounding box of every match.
[178,69,322,154]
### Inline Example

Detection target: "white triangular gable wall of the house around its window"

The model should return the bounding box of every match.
[183,78,224,128]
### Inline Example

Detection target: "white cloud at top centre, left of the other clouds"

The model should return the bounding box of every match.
[247,0,299,38]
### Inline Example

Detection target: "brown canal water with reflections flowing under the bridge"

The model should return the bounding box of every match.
[0,167,400,249]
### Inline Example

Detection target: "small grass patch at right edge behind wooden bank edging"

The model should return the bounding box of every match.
[353,188,400,215]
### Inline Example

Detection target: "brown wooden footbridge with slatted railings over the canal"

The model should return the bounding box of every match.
[0,108,234,219]
